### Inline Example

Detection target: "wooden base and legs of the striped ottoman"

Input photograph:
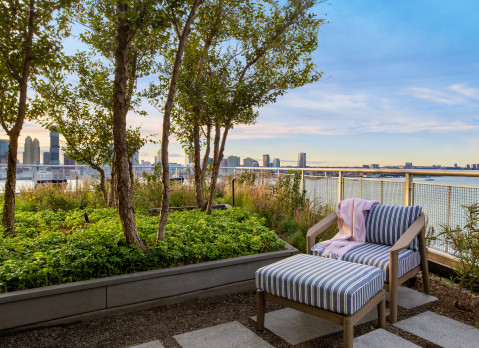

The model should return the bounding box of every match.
[256,289,386,348]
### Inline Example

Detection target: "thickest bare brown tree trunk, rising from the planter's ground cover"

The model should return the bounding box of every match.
[113,0,148,252]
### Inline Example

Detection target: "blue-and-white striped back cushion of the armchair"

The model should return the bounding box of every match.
[365,204,421,251]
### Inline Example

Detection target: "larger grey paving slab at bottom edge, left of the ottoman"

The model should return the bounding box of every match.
[173,321,273,348]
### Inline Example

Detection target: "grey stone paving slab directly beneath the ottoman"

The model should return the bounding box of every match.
[251,307,388,345]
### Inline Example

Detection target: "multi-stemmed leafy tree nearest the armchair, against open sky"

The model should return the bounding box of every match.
[171,0,323,212]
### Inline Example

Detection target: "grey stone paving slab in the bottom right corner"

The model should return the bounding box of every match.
[394,311,479,348]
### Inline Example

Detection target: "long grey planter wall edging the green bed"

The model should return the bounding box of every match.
[0,245,298,330]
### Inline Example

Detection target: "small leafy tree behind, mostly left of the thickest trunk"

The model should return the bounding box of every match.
[39,53,147,207]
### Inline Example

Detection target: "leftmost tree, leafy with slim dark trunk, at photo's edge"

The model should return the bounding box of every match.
[0,0,73,234]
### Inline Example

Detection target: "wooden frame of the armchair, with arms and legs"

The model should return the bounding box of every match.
[306,213,430,324]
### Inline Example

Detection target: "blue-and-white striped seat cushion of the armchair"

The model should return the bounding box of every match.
[311,243,421,283]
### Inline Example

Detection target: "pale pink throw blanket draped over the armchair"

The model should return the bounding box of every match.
[318,198,379,260]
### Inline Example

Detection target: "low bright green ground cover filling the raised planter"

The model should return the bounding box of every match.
[0,208,284,292]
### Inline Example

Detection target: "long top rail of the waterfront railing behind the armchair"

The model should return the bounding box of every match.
[227,167,479,177]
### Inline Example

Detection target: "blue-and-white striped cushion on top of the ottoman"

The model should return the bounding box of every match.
[256,254,384,315]
